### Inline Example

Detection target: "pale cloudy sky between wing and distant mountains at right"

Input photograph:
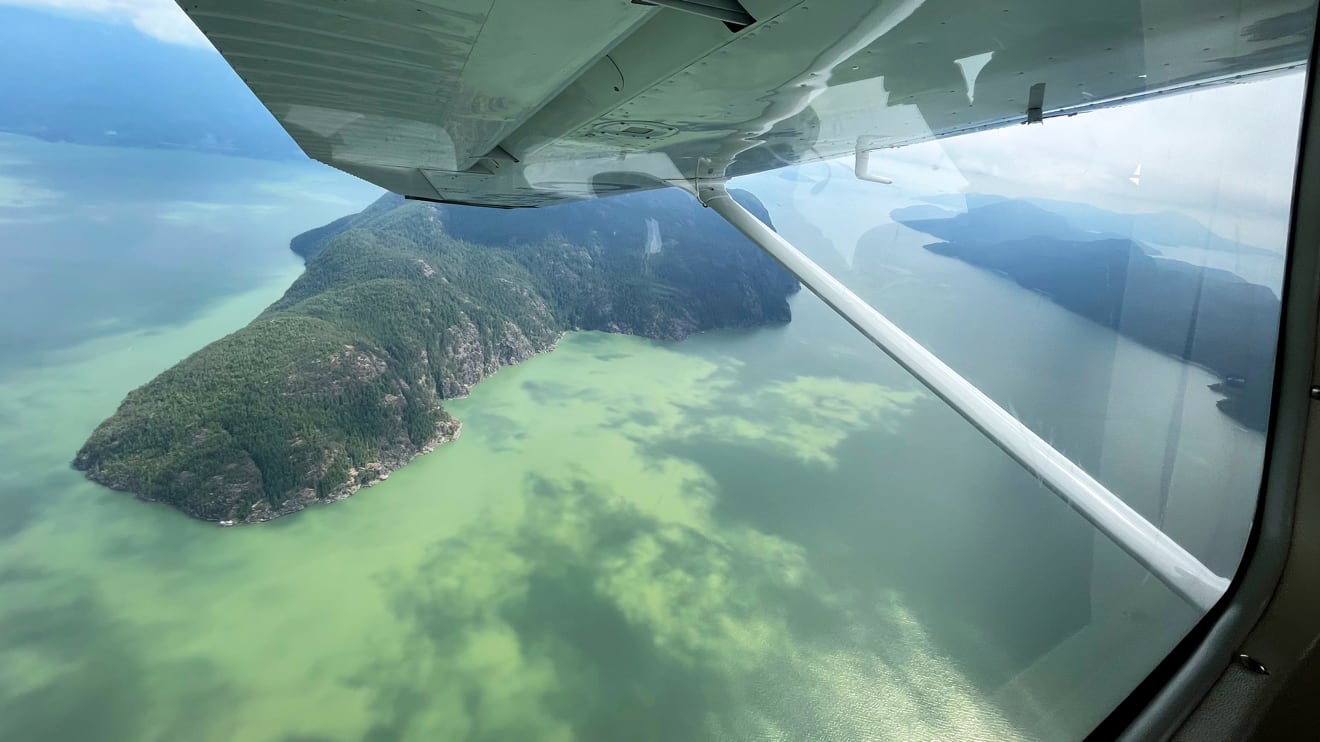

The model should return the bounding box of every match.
[735,71,1305,255]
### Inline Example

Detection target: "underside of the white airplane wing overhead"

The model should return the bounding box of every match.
[178,0,1315,207]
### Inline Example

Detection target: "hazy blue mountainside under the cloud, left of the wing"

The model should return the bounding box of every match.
[0,7,304,160]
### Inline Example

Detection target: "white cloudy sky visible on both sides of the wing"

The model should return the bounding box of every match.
[0,0,1304,250]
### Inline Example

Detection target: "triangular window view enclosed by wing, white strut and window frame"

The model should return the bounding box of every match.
[741,71,1305,583]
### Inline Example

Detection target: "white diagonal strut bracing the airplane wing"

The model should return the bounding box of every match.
[696,181,1229,611]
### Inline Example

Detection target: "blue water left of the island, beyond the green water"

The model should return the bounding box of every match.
[0,133,380,372]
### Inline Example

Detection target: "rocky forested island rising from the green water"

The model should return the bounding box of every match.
[73,190,799,524]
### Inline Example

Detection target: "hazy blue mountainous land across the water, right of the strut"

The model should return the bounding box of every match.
[892,199,1282,430]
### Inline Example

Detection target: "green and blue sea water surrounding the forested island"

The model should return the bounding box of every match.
[0,140,1263,741]
